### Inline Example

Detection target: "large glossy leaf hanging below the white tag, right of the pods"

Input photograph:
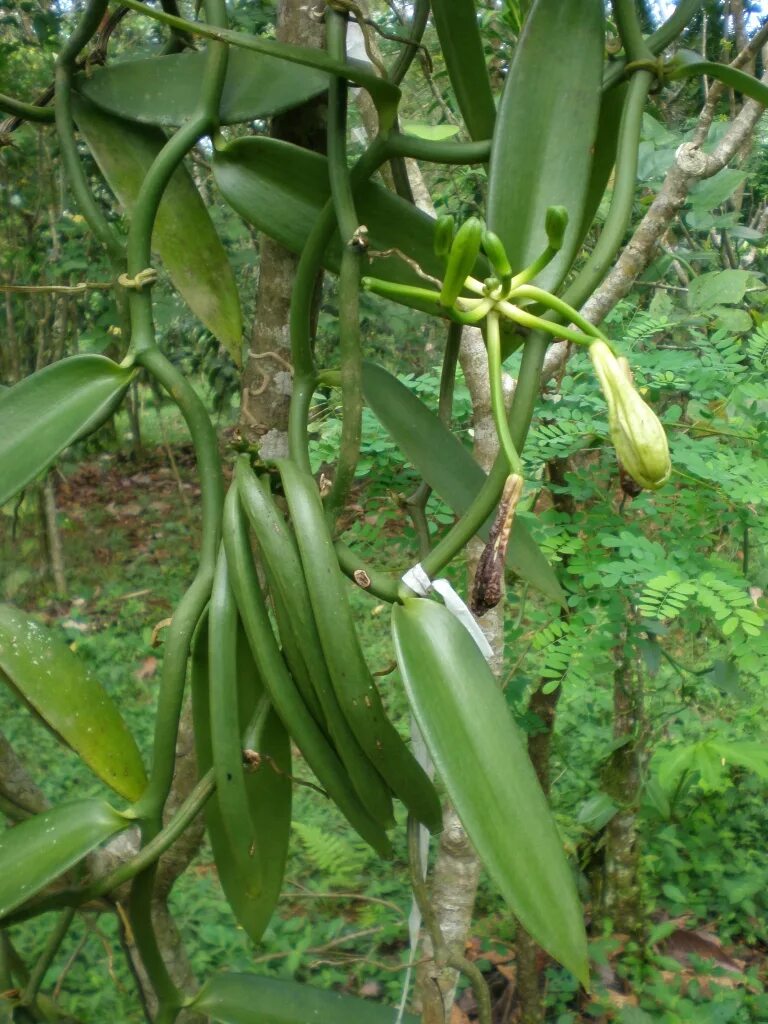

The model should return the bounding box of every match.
[392,598,589,984]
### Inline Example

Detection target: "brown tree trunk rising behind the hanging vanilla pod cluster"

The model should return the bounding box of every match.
[240,0,326,459]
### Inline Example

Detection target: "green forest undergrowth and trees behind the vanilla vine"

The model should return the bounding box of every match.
[0,0,768,1024]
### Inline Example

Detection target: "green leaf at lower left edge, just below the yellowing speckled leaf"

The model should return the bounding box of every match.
[0,800,131,918]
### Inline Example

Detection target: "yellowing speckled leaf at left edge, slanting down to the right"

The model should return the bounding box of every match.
[0,604,146,801]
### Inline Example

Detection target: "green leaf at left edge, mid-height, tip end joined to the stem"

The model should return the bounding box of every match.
[0,355,134,506]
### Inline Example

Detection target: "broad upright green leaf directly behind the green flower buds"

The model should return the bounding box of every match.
[487,0,605,291]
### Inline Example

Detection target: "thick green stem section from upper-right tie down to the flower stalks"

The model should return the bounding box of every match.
[562,71,653,306]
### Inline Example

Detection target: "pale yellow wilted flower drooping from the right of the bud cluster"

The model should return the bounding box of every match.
[590,341,672,490]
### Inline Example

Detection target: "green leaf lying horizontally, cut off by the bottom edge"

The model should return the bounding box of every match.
[189,974,419,1024]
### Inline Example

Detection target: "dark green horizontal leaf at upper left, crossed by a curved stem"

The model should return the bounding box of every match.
[76,47,330,128]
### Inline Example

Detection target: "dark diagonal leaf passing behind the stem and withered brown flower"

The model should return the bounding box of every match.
[362,362,564,601]
